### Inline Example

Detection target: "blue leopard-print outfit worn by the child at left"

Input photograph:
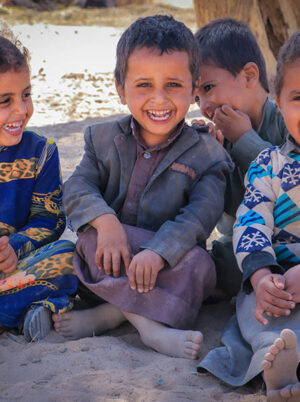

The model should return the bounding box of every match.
[0,131,77,327]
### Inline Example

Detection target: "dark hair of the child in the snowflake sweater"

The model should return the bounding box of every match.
[274,30,300,97]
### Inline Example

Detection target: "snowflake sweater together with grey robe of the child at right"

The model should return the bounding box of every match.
[198,136,300,386]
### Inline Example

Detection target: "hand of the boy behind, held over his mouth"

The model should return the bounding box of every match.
[213,105,252,143]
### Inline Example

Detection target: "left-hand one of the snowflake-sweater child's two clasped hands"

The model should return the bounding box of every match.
[251,268,295,325]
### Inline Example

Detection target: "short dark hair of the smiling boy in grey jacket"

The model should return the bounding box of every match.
[115,15,199,87]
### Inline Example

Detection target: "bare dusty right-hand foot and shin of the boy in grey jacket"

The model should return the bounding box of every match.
[123,311,203,359]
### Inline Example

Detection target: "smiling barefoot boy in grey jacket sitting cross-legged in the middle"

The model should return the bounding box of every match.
[53,15,232,358]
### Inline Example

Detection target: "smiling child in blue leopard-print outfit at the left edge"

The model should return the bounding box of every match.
[0,27,77,341]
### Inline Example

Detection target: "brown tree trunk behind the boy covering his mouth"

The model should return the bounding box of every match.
[194,0,300,77]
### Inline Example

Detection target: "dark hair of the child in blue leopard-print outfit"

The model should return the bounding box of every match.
[0,24,29,73]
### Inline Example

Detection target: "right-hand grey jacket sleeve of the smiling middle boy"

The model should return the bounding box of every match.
[142,138,234,267]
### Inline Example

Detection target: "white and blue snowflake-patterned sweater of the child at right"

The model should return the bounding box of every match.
[233,135,300,289]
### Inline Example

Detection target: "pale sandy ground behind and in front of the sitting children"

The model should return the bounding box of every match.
[0,6,266,402]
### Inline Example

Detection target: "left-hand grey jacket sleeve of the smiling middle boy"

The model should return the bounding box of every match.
[63,127,116,231]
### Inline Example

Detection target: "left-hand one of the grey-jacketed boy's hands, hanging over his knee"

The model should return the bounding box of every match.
[90,214,132,277]
